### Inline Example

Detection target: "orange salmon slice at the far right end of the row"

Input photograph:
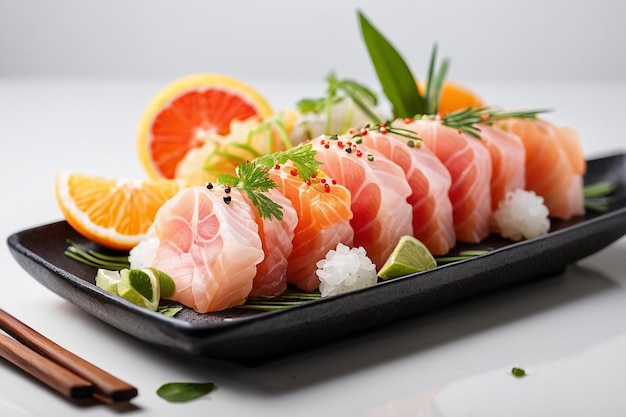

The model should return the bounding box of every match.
[496,119,587,220]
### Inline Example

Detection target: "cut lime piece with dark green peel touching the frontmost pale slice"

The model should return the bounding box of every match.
[117,268,160,311]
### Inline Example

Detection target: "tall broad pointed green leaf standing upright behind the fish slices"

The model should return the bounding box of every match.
[359,12,426,118]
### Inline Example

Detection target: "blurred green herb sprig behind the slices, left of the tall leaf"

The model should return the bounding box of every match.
[296,72,381,135]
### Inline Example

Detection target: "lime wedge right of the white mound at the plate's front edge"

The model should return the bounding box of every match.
[378,235,437,279]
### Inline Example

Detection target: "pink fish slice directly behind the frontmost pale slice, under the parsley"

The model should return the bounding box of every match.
[244,189,298,298]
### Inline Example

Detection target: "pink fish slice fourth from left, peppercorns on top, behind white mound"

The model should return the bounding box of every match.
[311,135,413,268]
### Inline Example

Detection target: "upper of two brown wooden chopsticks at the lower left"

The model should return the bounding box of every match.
[0,309,137,402]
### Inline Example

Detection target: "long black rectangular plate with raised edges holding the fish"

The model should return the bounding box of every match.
[7,154,626,364]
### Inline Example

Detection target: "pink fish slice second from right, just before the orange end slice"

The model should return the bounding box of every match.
[477,124,526,212]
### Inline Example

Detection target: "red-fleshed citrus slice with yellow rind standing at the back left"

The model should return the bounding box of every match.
[137,74,272,178]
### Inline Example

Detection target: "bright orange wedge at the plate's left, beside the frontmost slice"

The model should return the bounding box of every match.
[55,171,181,250]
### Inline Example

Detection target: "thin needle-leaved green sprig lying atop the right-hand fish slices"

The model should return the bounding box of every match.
[436,107,549,139]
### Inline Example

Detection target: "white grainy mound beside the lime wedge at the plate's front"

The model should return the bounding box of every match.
[316,243,378,297]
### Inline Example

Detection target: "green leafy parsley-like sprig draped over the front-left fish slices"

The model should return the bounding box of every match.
[217,144,320,220]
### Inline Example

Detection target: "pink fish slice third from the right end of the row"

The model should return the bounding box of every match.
[398,119,492,243]
